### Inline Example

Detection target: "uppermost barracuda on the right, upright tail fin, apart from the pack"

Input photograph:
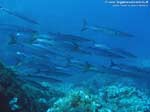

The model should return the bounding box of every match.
[81,20,134,37]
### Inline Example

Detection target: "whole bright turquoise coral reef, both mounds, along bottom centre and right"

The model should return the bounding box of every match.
[47,85,150,112]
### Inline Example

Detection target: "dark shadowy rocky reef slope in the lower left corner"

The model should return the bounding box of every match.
[0,63,63,112]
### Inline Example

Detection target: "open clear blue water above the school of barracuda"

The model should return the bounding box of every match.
[0,0,150,55]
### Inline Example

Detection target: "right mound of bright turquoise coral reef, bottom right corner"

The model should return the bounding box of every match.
[99,85,150,112]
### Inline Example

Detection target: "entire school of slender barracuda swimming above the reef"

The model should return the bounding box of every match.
[0,4,150,83]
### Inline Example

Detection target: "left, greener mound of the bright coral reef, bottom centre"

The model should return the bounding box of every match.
[47,90,99,112]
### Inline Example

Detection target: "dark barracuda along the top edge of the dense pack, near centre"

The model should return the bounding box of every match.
[49,32,93,43]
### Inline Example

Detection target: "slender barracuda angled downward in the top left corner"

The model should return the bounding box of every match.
[0,6,39,25]
